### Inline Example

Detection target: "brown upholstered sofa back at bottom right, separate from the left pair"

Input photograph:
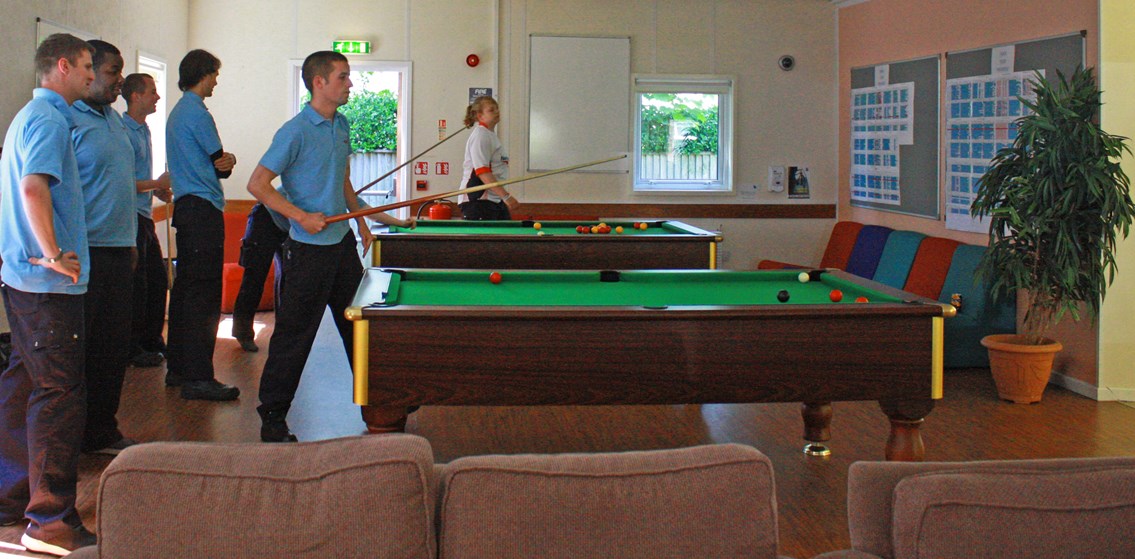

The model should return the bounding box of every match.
[839,457,1135,559]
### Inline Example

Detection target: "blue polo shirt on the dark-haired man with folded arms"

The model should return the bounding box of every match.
[166,91,225,211]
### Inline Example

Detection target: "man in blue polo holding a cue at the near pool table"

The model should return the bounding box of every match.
[249,51,413,442]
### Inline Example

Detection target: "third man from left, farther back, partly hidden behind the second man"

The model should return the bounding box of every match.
[123,74,173,366]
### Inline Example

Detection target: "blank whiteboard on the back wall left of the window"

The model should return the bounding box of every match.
[528,35,633,172]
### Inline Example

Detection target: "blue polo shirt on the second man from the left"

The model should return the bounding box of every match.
[72,101,137,247]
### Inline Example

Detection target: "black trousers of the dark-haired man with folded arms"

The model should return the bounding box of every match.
[166,196,225,381]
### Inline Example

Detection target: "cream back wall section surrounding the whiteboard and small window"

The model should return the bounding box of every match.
[501,0,839,269]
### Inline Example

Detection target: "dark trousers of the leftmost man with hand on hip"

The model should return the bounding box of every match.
[0,286,86,539]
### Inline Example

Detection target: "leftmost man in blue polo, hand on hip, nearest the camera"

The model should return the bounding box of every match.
[0,34,95,556]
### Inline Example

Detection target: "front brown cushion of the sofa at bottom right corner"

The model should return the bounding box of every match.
[894,466,1135,559]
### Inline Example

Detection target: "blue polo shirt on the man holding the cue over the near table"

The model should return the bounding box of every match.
[260,104,351,245]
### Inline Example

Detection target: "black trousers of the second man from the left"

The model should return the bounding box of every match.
[83,246,134,451]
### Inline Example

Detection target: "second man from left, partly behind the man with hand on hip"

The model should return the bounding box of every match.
[72,40,137,455]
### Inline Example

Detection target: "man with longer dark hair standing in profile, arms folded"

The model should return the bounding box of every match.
[166,49,241,400]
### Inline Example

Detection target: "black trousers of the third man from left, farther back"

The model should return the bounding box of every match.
[131,214,169,355]
